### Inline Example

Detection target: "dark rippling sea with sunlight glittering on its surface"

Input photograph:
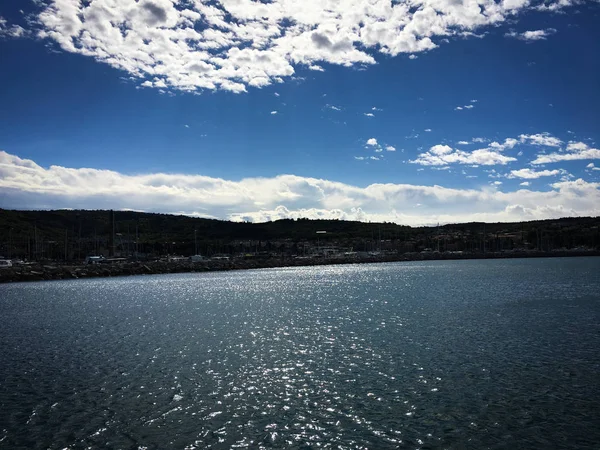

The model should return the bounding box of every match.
[0,257,600,450]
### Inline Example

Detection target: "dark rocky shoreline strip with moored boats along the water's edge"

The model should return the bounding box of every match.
[0,250,600,284]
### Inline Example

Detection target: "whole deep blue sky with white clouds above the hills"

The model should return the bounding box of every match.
[0,0,600,225]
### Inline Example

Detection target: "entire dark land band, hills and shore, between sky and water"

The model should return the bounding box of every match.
[0,210,600,282]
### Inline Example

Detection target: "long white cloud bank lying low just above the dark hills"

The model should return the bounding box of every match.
[0,152,600,225]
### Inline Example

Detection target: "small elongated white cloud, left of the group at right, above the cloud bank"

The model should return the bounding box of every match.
[410,143,517,166]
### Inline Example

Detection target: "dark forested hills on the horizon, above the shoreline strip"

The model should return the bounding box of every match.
[0,209,600,259]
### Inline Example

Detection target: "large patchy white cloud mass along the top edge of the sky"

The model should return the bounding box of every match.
[19,0,567,93]
